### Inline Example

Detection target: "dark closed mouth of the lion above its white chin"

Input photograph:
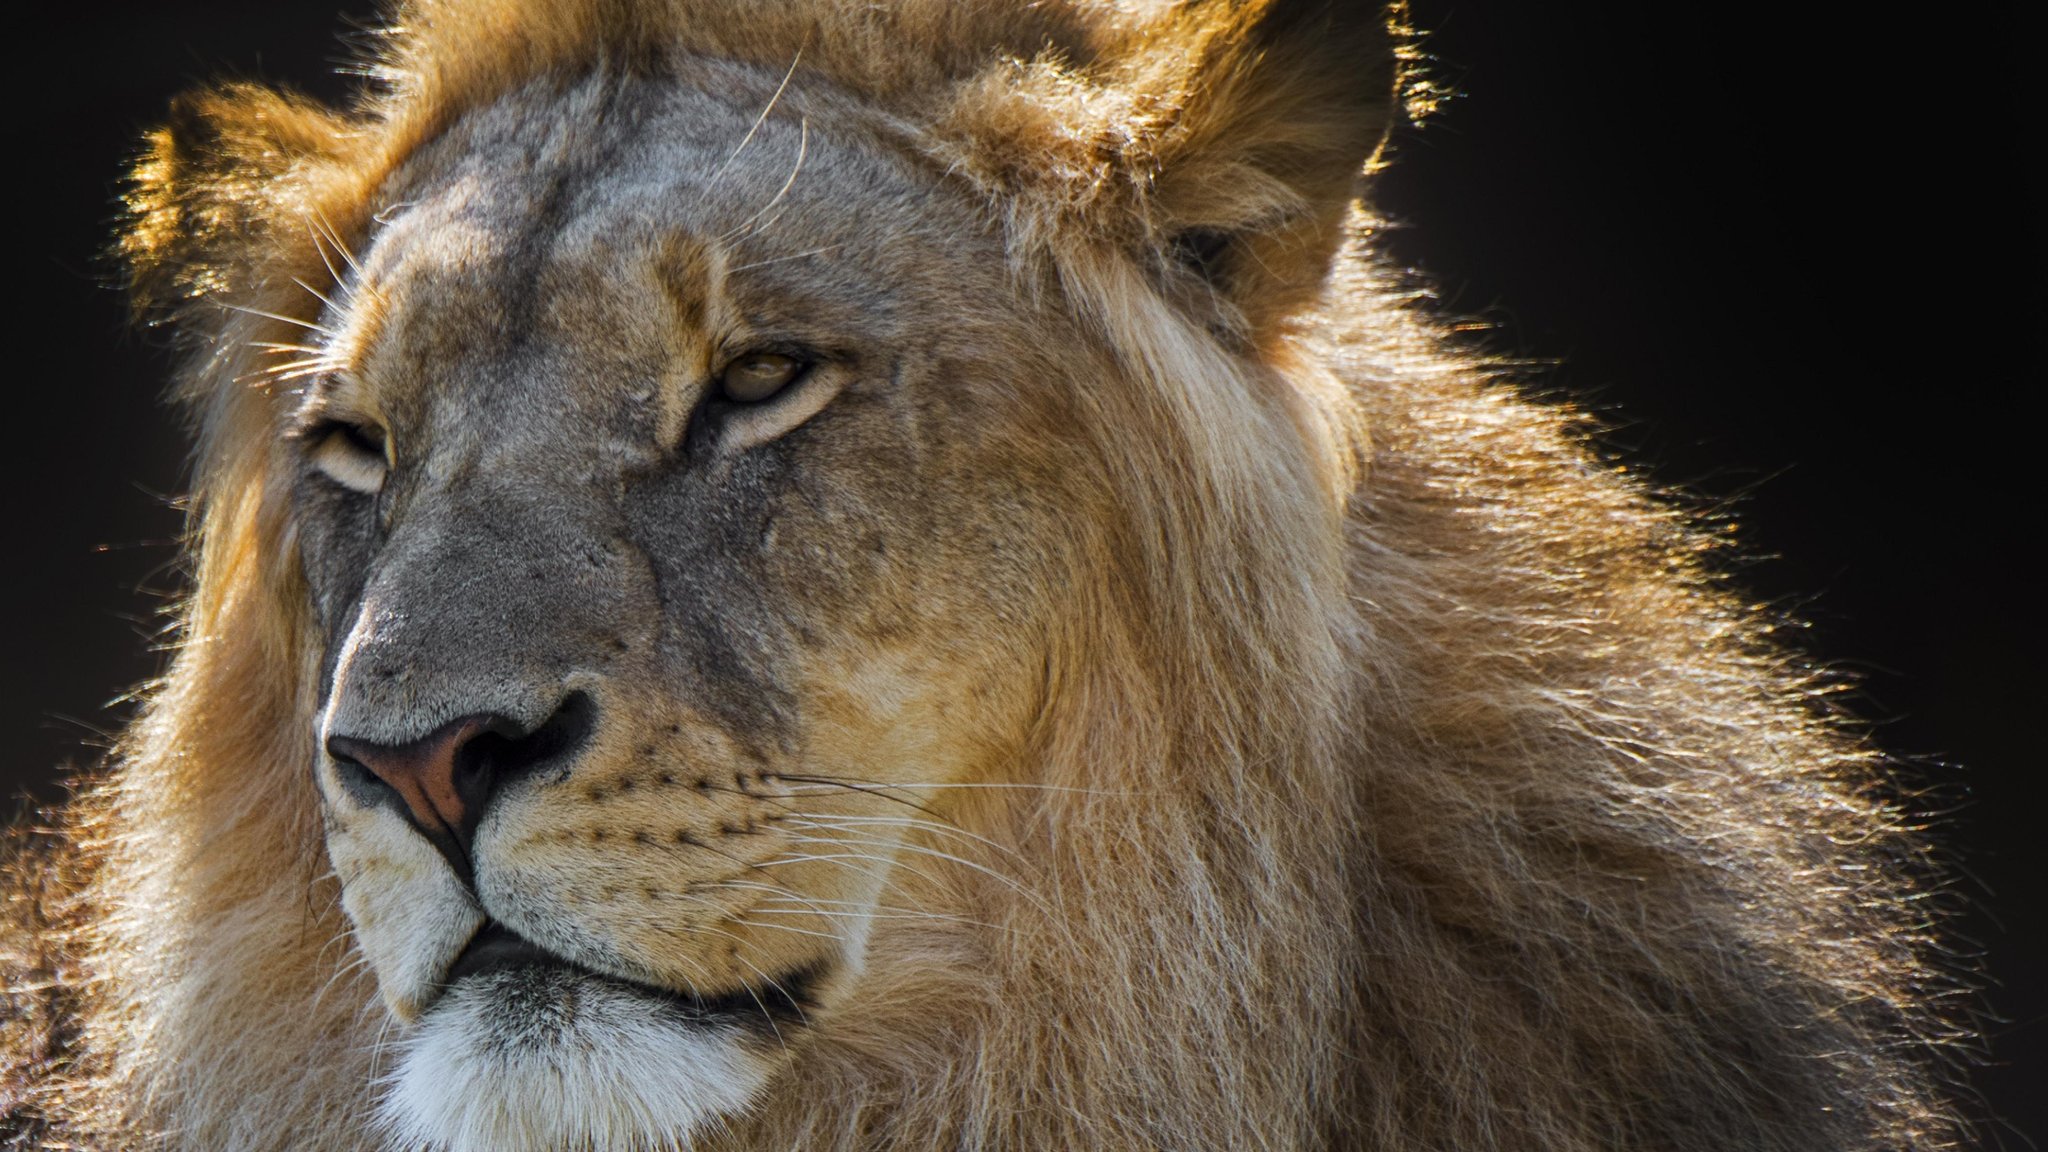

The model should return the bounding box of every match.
[442,920,825,1035]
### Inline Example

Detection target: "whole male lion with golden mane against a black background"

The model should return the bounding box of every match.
[0,0,1962,1152]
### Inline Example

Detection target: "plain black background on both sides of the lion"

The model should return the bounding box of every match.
[0,0,2048,1148]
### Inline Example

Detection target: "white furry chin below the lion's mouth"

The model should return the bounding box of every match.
[379,968,766,1152]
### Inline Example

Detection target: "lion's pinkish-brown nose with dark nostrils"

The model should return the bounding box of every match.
[328,693,594,873]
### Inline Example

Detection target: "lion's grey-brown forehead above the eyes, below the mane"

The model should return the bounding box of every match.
[365,84,1001,326]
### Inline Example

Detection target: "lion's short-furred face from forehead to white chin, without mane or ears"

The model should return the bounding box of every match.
[301,76,1094,1148]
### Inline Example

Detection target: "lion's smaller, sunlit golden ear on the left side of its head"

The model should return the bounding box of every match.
[115,84,350,314]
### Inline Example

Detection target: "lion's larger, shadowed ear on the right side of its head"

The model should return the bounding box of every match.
[1128,0,1399,332]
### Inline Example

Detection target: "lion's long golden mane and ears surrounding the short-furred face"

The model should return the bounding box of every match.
[0,0,1958,1152]
